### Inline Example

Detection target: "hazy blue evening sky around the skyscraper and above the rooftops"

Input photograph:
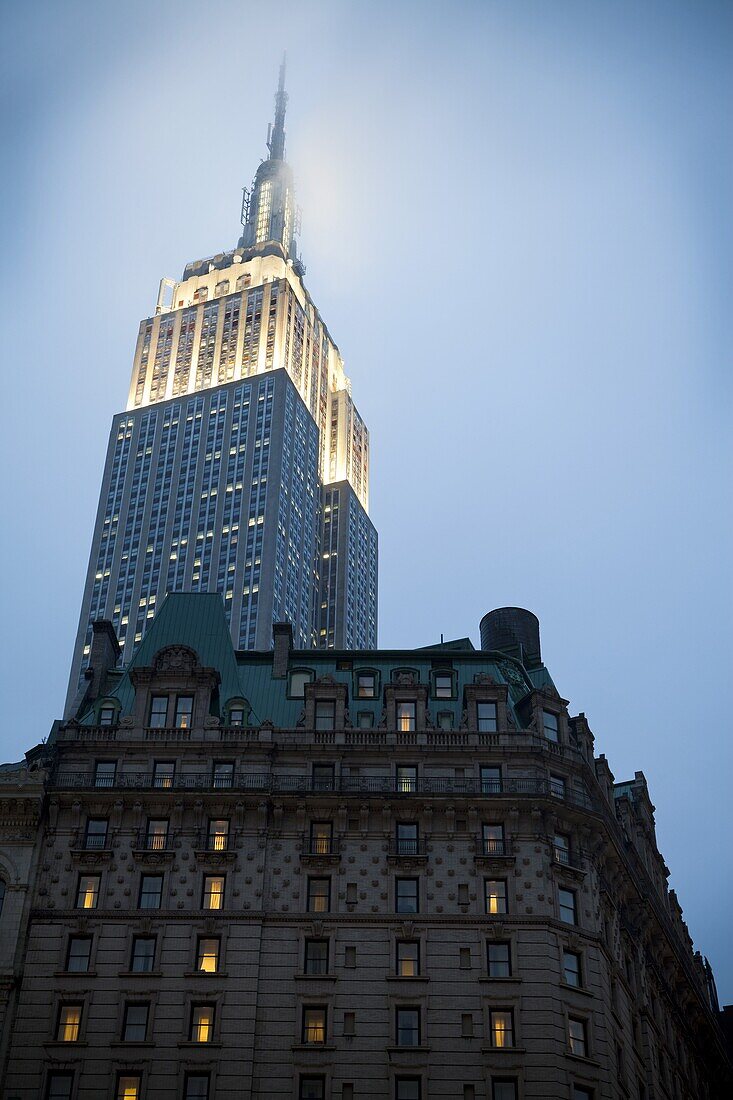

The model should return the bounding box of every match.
[0,0,733,1001]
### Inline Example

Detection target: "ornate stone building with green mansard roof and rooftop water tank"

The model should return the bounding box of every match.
[0,594,731,1100]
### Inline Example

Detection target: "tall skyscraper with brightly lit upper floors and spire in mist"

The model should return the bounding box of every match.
[68,63,378,705]
